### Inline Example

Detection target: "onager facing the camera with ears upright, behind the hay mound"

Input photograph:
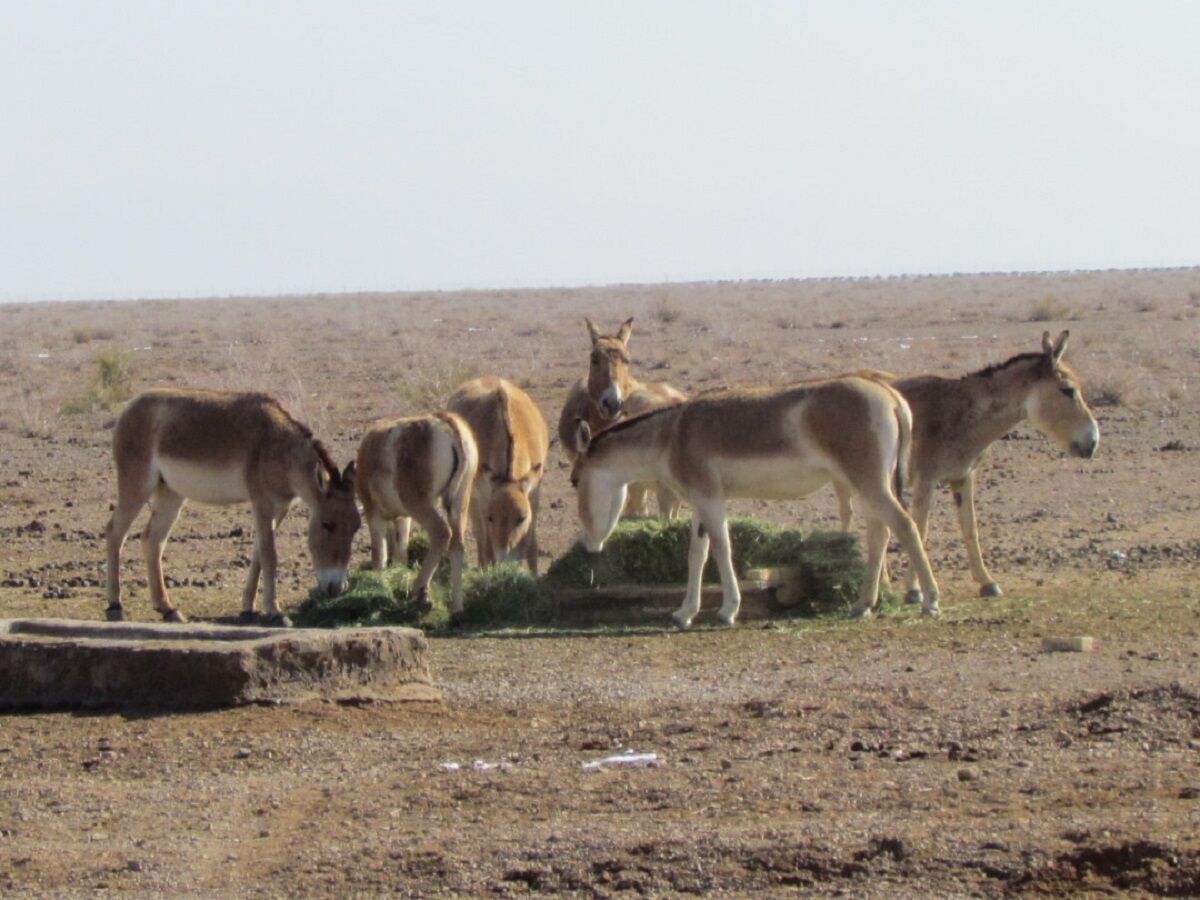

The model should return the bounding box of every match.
[558,319,686,518]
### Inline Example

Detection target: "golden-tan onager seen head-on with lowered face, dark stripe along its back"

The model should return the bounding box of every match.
[446,378,550,575]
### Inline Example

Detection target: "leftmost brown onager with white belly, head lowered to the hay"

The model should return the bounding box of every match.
[106,389,361,625]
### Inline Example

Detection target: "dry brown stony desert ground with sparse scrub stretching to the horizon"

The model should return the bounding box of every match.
[0,270,1200,896]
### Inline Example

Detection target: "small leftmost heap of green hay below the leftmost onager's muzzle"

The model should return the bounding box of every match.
[290,565,450,630]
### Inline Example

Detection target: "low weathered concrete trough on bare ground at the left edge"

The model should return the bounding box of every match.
[0,619,440,709]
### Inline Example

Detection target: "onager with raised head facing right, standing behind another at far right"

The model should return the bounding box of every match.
[834,331,1100,602]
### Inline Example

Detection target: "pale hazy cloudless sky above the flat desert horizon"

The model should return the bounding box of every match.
[0,0,1200,300]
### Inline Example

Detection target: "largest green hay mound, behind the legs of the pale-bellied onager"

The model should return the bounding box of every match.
[546,518,865,612]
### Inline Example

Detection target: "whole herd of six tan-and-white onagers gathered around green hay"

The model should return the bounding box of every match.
[106,319,1099,628]
